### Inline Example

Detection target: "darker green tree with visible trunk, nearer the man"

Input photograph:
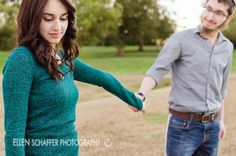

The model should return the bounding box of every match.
[116,0,174,55]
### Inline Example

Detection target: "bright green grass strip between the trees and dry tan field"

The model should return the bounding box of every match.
[0,46,236,74]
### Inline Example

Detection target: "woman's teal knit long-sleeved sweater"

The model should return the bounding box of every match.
[2,46,142,156]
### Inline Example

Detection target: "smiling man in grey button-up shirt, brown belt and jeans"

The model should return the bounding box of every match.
[133,0,235,156]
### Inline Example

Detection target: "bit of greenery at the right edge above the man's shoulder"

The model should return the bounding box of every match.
[224,12,236,48]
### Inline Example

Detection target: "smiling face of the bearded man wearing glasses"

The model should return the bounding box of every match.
[201,0,229,31]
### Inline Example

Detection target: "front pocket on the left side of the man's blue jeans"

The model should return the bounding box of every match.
[170,115,190,129]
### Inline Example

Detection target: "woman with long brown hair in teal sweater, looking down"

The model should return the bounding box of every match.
[3,0,145,156]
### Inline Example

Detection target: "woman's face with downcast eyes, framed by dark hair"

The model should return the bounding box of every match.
[39,0,68,48]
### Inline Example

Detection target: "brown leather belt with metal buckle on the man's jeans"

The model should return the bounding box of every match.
[169,108,219,123]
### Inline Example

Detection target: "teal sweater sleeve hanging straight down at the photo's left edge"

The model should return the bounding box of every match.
[2,49,33,156]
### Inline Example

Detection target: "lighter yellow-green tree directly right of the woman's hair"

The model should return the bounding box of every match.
[76,0,121,45]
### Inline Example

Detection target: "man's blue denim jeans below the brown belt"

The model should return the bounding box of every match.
[166,115,220,156]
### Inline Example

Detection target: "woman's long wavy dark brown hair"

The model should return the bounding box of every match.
[17,0,79,80]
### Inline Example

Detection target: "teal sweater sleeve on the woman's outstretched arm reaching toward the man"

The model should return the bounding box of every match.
[74,59,143,110]
